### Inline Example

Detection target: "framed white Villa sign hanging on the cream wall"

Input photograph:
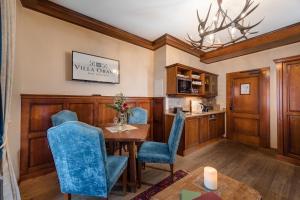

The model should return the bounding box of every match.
[72,51,120,84]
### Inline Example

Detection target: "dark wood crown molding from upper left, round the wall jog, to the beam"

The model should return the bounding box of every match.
[21,0,201,57]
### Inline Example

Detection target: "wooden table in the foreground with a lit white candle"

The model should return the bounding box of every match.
[152,167,261,200]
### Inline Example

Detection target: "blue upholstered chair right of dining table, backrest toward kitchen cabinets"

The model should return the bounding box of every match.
[137,111,185,185]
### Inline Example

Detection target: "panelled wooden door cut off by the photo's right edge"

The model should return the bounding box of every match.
[283,59,300,159]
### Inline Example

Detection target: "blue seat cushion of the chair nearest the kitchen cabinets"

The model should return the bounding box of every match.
[138,142,171,163]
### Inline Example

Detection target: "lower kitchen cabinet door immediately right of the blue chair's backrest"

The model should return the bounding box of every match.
[185,118,199,148]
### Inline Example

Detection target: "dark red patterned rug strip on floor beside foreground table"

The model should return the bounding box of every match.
[131,170,188,200]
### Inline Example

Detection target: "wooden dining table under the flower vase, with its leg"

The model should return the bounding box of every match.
[99,124,150,192]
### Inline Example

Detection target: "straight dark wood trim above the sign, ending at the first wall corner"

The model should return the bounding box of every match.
[21,0,153,50]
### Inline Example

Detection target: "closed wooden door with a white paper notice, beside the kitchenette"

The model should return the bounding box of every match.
[226,68,270,147]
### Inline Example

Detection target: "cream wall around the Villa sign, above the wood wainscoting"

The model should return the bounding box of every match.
[8,1,154,180]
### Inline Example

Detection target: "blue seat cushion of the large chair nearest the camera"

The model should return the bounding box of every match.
[107,156,128,191]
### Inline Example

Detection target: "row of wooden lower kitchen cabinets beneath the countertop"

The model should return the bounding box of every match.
[165,113,225,156]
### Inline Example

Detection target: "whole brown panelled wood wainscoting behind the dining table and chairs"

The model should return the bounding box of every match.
[20,94,164,181]
